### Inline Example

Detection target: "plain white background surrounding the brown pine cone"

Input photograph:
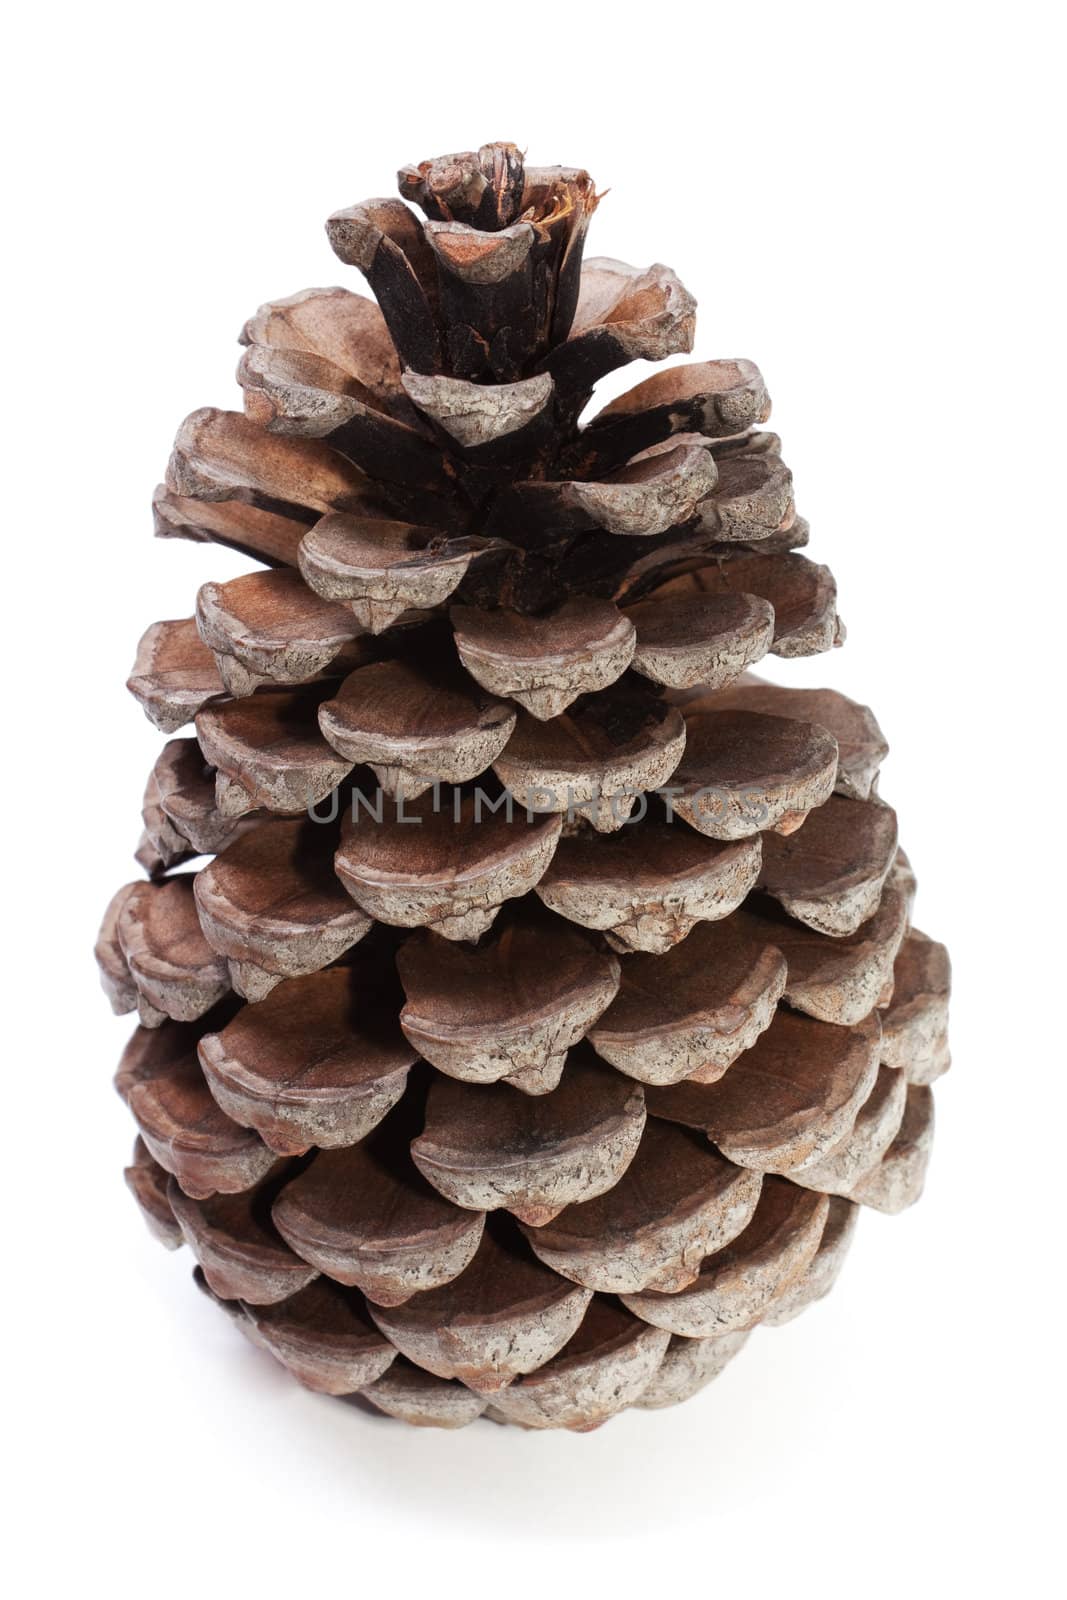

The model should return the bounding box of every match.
[2,0,1067,1597]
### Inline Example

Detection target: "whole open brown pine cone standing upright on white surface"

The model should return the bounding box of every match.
[98,144,949,1430]
